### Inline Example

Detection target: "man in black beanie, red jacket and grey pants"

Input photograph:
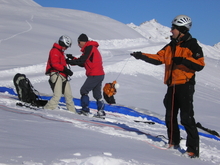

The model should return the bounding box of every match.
[66,34,105,117]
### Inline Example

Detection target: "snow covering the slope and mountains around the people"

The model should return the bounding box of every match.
[0,0,220,165]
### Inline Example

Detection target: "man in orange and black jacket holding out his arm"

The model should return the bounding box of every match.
[131,15,205,158]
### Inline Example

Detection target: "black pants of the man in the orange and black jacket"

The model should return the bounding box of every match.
[164,83,199,156]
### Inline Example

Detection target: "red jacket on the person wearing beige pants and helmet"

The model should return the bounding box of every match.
[46,43,67,77]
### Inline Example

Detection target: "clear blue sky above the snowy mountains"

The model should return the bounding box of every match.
[34,0,220,46]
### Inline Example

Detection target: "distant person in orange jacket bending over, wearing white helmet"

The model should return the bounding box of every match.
[103,80,119,104]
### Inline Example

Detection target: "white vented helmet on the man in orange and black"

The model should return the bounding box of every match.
[172,15,192,31]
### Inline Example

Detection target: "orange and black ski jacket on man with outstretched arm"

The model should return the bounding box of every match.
[141,33,205,86]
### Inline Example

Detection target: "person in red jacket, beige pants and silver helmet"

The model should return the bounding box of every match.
[44,35,76,113]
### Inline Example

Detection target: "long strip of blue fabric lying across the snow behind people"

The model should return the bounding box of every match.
[0,87,220,141]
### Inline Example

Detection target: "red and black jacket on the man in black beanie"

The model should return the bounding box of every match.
[70,41,105,76]
